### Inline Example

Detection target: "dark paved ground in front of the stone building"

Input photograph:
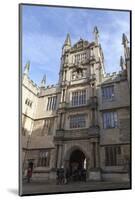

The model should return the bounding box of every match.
[22,181,130,195]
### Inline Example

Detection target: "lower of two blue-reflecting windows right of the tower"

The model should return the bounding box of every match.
[103,112,118,129]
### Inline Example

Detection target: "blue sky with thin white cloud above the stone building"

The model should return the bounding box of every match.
[22,5,130,85]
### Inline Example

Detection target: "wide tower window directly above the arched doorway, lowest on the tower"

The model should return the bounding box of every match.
[70,114,86,128]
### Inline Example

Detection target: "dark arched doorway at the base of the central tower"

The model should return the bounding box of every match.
[69,149,86,181]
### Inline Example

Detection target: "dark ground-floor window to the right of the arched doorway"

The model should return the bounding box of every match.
[105,145,121,166]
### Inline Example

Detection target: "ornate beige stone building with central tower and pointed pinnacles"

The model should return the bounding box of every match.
[21,27,130,181]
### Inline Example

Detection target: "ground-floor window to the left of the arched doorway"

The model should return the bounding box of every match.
[38,150,50,167]
